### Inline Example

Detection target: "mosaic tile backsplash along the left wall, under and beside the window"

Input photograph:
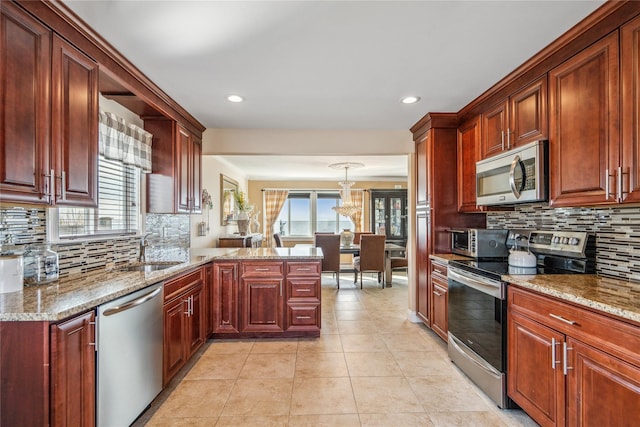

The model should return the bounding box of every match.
[0,207,190,276]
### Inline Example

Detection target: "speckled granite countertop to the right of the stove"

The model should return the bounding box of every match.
[502,274,640,323]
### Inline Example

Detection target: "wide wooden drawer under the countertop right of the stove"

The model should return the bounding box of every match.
[508,285,640,365]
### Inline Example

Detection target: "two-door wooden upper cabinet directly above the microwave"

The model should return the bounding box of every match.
[480,75,548,159]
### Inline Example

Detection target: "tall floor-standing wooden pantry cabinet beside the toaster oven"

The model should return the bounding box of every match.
[411,113,485,327]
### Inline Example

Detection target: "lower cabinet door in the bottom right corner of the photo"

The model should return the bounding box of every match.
[567,338,640,426]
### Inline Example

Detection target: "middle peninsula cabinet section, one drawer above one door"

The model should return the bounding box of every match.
[240,261,284,334]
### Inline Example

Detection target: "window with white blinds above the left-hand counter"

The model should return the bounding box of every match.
[48,156,140,239]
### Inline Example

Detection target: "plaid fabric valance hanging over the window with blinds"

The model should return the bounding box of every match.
[98,111,153,172]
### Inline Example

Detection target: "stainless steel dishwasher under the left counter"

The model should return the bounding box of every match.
[96,283,163,427]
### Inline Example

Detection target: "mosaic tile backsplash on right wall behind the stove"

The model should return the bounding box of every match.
[487,203,640,283]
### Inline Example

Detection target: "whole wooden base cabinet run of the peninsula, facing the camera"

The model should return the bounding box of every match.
[210,260,321,338]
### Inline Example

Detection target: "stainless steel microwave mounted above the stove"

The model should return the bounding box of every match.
[476,140,549,206]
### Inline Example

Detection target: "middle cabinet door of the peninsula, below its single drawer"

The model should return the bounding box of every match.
[241,277,284,332]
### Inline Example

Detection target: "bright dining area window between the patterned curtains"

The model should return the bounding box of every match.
[275,191,353,237]
